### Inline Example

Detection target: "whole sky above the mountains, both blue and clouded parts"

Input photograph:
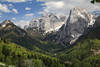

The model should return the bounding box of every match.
[0,0,100,26]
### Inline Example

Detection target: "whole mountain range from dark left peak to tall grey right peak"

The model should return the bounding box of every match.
[0,8,99,47]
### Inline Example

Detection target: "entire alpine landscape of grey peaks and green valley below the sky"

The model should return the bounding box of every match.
[0,8,100,67]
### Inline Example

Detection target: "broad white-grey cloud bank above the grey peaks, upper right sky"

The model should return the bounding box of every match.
[37,0,100,15]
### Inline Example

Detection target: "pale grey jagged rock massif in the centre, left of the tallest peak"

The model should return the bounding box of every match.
[27,14,66,33]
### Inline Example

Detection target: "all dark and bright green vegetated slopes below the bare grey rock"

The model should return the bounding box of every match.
[0,20,100,67]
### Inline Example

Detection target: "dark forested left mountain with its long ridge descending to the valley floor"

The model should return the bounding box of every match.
[0,20,63,53]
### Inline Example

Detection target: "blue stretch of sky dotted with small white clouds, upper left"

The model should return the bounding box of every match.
[0,0,45,21]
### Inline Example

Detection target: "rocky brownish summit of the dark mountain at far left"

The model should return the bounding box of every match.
[0,20,27,37]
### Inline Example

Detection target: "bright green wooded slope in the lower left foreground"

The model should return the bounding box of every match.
[0,40,65,67]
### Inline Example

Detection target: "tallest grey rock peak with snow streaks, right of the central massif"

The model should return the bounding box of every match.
[56,8,95,45]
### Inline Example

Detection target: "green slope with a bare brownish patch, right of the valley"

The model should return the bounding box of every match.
[58,28,100,67]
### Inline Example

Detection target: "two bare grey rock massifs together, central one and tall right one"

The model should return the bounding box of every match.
[25,8,96,45]
